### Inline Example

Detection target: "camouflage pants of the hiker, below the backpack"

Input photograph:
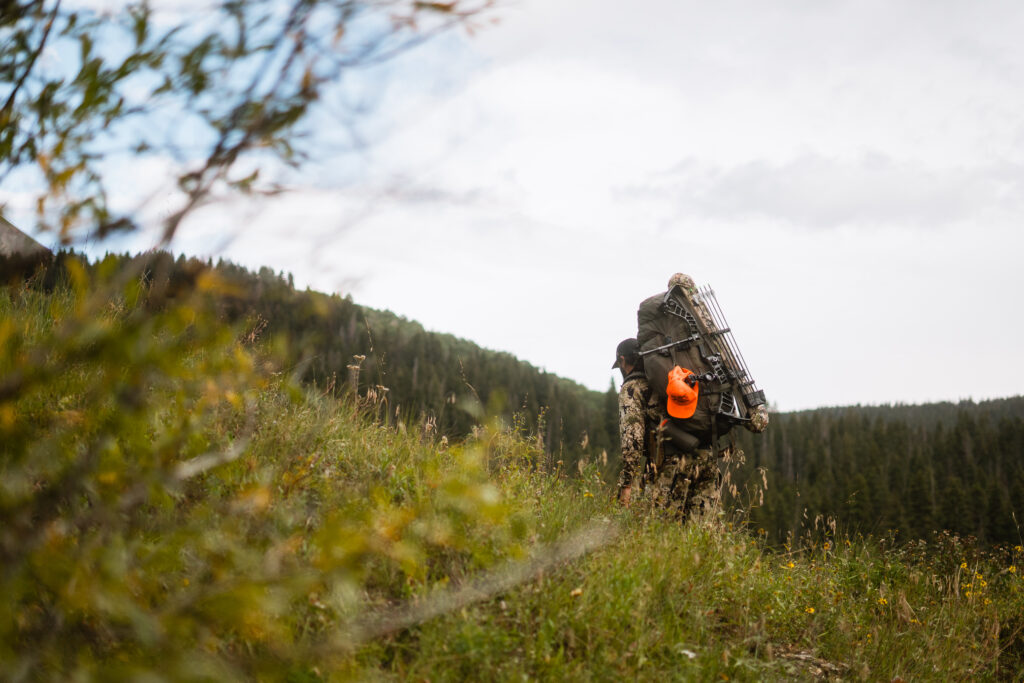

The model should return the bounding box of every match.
[650,449,722,521]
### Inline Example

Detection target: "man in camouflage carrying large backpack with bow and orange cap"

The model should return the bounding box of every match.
[613,273,768,520]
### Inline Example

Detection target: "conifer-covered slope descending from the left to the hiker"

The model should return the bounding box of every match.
[16,252,618,467]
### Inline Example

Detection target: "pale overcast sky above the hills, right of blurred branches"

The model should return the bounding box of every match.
[19,0,1024,411]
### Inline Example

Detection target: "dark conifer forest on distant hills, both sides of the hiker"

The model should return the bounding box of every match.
[12,248,1024,545]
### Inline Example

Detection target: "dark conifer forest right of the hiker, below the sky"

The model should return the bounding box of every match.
[737,397,1024,544]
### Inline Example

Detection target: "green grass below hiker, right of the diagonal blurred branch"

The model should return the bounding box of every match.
[362,513,1024,680]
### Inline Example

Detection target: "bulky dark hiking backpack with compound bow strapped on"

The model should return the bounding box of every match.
[637,273,768,452]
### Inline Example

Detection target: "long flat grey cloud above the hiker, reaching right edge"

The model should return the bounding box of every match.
[640,154,1024,229]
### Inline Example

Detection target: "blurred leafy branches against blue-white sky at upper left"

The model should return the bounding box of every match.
[0,0,492,244]
